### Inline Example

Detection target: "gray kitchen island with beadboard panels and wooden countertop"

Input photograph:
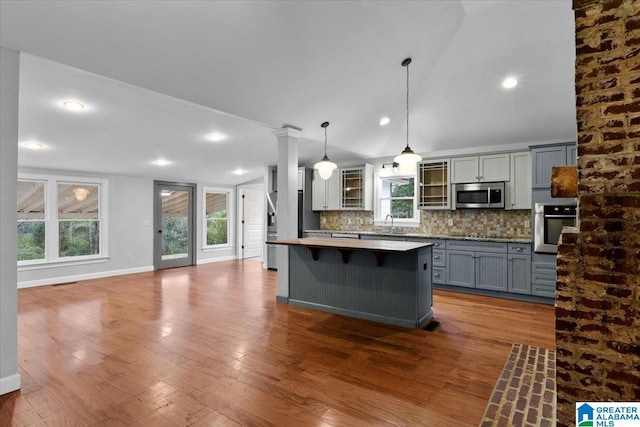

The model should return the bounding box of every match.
[268,238,433,329]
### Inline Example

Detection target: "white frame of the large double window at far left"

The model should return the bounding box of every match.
[17,173,109,271]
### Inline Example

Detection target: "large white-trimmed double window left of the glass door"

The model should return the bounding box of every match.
[17,174,107,266]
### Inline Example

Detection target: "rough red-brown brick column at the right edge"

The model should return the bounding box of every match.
[556,0,640,426]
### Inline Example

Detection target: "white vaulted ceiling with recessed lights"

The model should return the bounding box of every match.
[0,0,576,184]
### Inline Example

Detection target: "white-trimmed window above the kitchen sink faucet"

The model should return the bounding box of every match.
[374,175,420,227]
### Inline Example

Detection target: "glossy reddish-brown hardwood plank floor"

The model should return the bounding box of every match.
[0,261,555,427]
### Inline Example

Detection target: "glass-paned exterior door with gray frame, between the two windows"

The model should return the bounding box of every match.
[153,181,196,270]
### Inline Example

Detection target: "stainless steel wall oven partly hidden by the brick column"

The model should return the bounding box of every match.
[533,203,577,254]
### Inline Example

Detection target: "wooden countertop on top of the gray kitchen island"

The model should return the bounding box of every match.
[267,237,432,252]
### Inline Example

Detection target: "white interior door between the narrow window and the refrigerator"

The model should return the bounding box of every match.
[240,188,264,259]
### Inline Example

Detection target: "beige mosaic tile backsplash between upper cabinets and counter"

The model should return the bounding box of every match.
[320,209,531,239]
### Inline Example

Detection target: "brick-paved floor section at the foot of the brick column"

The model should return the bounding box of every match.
[480,344,556,427]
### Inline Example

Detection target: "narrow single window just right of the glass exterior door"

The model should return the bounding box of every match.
[204,189,231,248]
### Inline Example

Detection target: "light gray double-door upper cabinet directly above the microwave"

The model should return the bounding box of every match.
[451,153,510,184]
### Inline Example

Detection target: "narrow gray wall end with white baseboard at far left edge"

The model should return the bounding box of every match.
[0,47,20,394]
